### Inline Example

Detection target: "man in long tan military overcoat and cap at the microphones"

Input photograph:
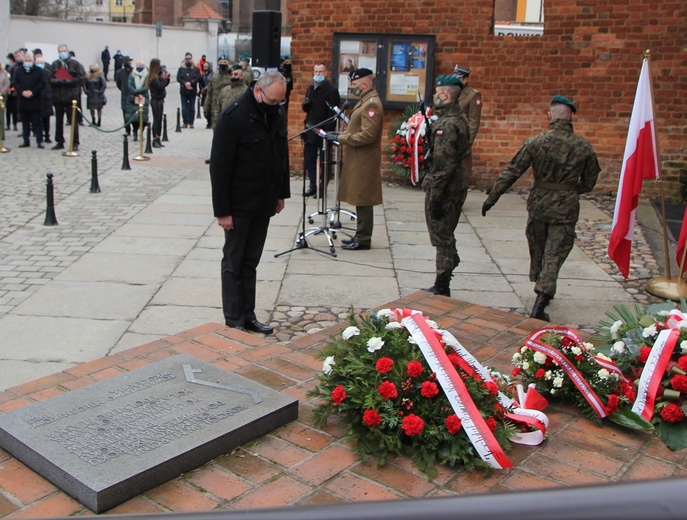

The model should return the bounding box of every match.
[327,68,384,251]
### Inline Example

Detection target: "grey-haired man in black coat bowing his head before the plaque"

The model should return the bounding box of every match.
[210,71,291,334]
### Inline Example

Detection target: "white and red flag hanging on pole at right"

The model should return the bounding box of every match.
[608,59,659,278]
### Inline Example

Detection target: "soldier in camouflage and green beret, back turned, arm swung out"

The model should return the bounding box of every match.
[482,96,601,321]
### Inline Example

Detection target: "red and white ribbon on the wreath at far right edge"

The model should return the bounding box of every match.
[632,329,680,421]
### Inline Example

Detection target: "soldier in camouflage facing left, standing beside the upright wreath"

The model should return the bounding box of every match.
[422,74,470,296]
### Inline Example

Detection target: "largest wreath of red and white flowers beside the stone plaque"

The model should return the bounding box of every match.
[309,309,548,476]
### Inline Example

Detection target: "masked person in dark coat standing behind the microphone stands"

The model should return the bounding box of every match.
[301,63,341,197]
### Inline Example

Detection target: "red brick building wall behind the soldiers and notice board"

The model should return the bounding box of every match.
[289,0,687,200]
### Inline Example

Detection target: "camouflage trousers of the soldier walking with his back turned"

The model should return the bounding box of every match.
[525,216,575,298]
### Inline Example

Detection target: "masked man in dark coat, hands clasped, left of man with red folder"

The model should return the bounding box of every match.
[14,51,45,148]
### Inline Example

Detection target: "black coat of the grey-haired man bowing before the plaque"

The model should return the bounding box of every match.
[210,83,291,217]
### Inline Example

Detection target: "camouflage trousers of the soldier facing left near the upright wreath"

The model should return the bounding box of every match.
[425,189,468,275]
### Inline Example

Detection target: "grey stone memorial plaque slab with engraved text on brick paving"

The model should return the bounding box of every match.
[0,354,298,513]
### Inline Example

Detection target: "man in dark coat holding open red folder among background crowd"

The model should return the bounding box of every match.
[50,43,86,151]
